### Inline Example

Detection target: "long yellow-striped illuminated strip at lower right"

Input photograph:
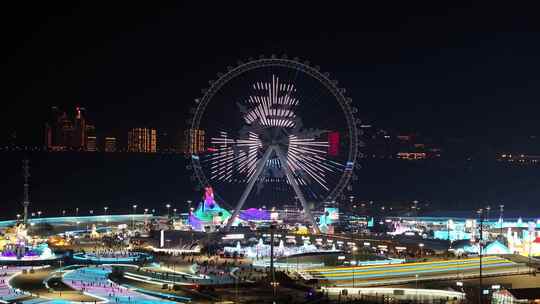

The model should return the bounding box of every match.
[305,256,528,286]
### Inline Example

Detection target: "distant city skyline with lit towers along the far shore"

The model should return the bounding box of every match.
[0,105,540,158]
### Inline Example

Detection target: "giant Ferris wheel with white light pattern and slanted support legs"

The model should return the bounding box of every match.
[188,56,362,233]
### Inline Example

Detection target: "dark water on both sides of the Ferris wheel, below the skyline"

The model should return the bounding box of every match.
[0,153,540,218]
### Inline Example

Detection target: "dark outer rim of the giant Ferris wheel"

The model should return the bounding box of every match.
[190,56,361,201]
